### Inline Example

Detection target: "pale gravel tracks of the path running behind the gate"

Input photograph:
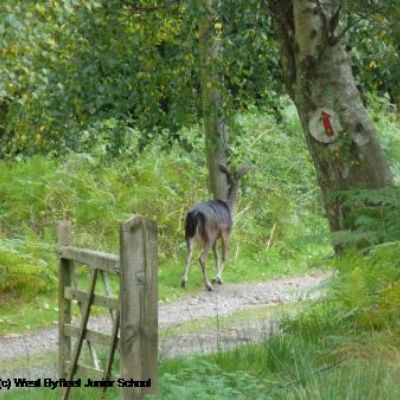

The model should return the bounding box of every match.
[0,273,330,373]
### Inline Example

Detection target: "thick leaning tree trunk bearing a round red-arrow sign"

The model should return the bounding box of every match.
[267,0,392,245]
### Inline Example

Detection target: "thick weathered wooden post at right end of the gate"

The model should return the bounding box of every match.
[120,216,158,400]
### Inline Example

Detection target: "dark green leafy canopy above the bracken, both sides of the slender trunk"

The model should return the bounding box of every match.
[0,0,280,157]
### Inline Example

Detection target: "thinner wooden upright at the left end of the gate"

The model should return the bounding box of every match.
[57,221,72,378]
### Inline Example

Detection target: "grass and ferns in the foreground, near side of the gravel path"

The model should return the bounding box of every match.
[153,242,400,400]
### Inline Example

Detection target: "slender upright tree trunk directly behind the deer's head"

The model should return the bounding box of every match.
[199,0,228,200]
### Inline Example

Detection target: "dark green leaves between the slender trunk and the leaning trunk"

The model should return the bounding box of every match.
[216,0,284,110]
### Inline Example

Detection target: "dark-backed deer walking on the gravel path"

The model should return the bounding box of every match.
[181,164,252,291]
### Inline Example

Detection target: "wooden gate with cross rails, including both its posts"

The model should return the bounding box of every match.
[58,216,158,400]
